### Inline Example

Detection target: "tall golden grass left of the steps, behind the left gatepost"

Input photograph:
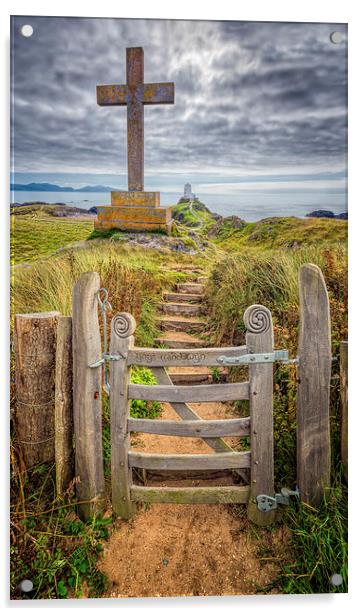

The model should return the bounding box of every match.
[12,243,188,345]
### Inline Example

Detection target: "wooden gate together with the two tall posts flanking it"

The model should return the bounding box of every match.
[72,264,331,525]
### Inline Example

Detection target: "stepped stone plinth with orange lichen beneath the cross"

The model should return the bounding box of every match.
[95,191,172,234]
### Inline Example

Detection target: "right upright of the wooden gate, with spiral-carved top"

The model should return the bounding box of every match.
[243,304,276,526]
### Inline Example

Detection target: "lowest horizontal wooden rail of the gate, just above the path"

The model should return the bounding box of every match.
[130,485,250,505]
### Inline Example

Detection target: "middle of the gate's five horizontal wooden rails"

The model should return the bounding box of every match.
[127,417,250,438]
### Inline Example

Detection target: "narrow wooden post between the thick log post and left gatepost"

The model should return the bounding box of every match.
[54,317,74,496]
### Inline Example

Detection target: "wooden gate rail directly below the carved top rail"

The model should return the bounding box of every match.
[128,381,249,402]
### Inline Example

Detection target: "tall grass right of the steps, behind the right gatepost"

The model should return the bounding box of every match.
[206,244,347,353]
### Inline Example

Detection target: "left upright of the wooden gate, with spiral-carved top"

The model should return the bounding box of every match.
[110,312,136,520]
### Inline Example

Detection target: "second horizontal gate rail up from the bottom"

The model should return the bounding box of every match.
[128,451,251,471]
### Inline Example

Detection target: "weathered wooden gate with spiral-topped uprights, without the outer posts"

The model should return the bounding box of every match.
[106,305,275,524]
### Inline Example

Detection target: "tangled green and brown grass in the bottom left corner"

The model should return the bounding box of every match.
[10,450,112,599]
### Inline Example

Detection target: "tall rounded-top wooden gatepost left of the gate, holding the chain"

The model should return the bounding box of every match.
[72,272,105,520]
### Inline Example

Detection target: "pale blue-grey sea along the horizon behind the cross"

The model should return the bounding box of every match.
[11,190,346,222]
